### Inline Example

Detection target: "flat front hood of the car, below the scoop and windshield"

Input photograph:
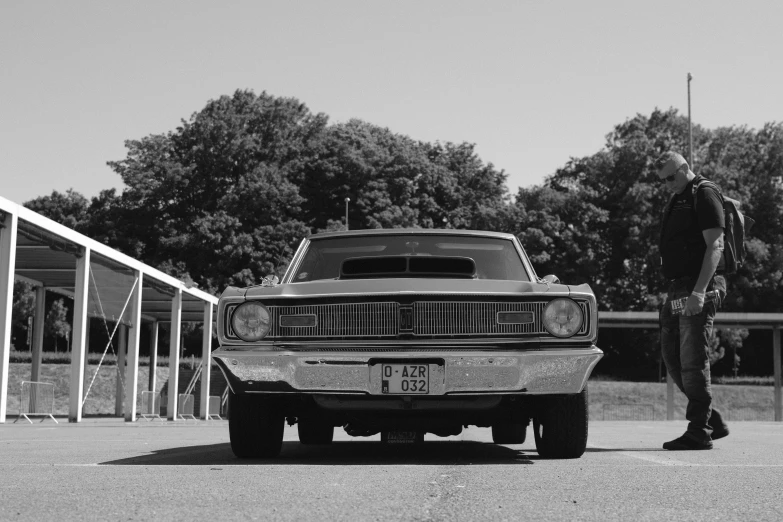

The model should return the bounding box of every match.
[233,278,592,298]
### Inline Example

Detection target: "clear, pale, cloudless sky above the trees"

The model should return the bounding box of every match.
[0,0,783,203]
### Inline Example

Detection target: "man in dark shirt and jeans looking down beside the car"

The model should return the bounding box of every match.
[655,152,729,450]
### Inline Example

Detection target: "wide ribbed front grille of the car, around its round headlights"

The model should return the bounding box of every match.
[226,301,590,340]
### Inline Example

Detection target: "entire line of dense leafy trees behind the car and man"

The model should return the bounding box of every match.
[12,90,783,369]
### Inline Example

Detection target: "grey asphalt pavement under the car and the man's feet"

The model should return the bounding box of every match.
[0,419,783,522]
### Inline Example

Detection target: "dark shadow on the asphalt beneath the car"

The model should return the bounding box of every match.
[99,441,539,466]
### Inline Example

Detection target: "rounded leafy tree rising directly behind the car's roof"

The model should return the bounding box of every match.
[299,119,508,230]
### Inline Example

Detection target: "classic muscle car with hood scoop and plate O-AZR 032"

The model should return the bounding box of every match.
[212,229,603,458]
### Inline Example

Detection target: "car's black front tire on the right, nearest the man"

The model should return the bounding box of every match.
[533,388,588,459]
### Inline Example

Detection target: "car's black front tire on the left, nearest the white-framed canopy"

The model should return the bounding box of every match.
[228,391,285,459]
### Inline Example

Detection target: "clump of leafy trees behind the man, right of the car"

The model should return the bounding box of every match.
[536,109,783,374]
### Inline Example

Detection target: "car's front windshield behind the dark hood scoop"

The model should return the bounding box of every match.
[291,234,530,283]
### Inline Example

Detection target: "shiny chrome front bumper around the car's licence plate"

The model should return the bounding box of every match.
[212,346,603,395]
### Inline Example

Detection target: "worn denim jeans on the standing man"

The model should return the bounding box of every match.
[660,276,726,441]
